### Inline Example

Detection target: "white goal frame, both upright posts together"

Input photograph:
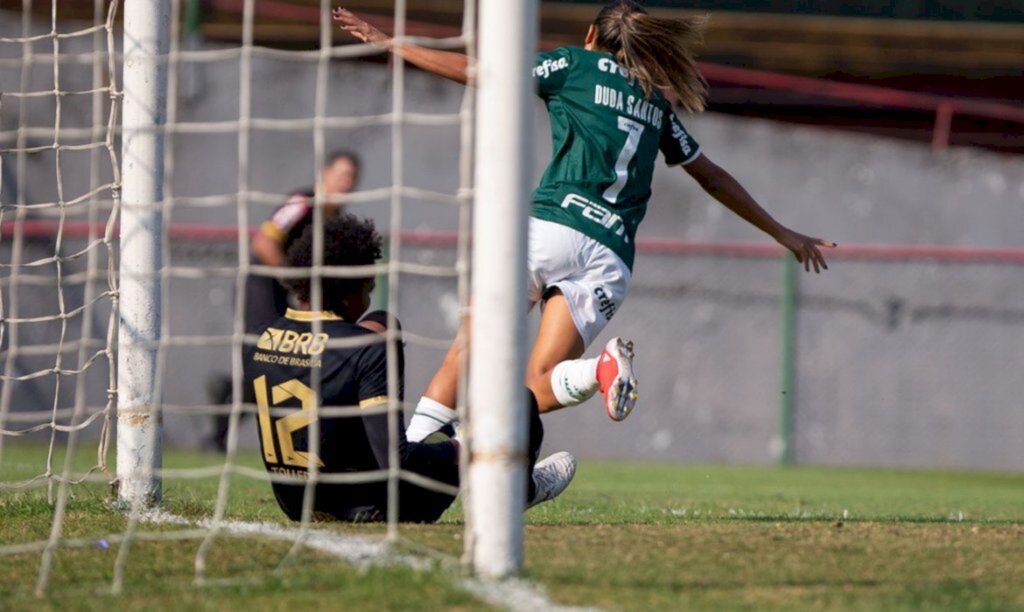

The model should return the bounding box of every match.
[117,0,537,577]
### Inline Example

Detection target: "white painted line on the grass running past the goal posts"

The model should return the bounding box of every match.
[141,510,593,612]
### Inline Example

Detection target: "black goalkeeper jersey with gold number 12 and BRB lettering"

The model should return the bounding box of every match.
[244,309,458,520]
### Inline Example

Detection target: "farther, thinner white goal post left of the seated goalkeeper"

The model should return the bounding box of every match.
[117,0,171,505]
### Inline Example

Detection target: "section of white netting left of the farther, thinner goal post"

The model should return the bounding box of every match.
[0,3,120,501]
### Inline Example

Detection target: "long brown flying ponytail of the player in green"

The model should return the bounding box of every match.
[594,0,708,113]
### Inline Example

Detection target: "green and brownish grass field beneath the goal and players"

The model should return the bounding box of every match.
[0,445,1024,612]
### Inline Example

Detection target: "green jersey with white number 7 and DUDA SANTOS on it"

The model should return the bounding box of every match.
[530,47,700,269]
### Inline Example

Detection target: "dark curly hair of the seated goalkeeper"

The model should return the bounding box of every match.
[287,213,382,312]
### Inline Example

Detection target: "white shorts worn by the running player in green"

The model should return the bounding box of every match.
[526,217,633,347]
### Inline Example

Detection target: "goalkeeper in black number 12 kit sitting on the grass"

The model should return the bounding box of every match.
[245,214,575,522]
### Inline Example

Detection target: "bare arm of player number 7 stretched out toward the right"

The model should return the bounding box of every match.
[683,155,836,272]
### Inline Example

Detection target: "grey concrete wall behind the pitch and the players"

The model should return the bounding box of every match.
[0,25,1024,470]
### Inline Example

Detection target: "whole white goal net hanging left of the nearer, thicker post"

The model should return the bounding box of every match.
[0,0,474,594]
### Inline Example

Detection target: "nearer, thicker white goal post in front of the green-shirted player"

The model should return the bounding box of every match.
[468,0,537,577]
